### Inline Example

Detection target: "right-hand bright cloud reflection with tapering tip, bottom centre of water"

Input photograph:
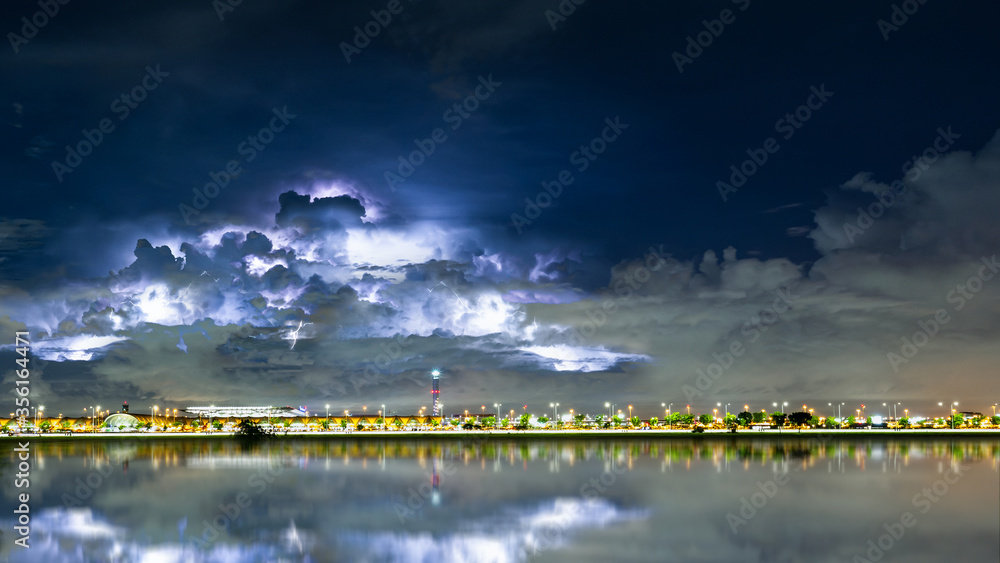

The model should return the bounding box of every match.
[340,498,649,563]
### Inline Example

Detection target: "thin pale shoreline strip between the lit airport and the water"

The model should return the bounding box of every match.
[0,428,1000,444]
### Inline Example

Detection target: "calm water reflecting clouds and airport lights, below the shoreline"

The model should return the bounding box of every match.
[0,436,1000,563]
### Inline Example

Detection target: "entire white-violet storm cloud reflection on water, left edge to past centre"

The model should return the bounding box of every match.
[0,498,649,563]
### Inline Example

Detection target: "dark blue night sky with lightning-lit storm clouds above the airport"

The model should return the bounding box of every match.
[0,0,1000,416]
